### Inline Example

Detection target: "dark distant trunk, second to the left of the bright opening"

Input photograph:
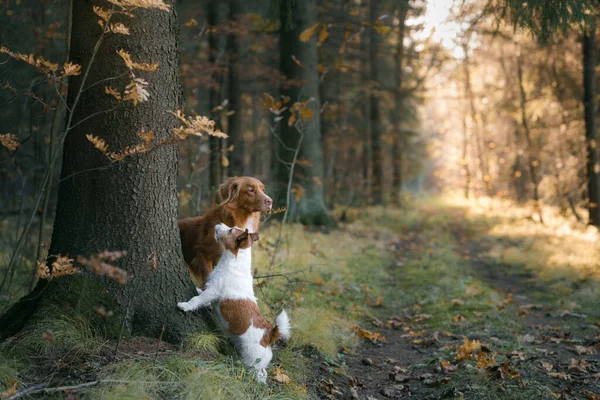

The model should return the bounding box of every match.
[369,0,384,204]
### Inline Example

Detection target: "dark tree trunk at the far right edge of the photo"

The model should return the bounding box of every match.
[583,24,600,226]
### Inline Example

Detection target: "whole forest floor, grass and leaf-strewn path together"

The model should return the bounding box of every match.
[0,199,600,400]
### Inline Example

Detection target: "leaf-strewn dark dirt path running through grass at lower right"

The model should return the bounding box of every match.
[337,208,600,400]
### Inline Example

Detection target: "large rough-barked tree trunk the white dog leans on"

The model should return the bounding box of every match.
[0,1,201,342]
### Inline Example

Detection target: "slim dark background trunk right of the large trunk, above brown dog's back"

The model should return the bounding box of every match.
[207,0,223,195]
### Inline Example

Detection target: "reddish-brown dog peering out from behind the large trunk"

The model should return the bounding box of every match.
[179,176,273,289]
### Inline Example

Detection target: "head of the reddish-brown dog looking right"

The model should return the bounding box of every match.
[219,176,273,213]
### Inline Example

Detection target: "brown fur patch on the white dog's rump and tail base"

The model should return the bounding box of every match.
[219,299,281,347]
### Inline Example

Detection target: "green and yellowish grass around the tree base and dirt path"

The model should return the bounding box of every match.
[0,199,600,399]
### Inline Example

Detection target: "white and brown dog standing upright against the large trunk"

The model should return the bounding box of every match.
[177,224,291,383]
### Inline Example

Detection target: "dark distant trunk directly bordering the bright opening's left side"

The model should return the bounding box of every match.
[392,0,409,205]
